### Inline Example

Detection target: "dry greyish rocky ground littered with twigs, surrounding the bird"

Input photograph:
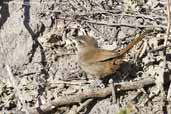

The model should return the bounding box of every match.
[0,0,171,114]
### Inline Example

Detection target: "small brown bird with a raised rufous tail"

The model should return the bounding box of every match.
[75,31,152,79]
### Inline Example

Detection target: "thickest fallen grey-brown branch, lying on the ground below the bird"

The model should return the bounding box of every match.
[26,77,155,114]
